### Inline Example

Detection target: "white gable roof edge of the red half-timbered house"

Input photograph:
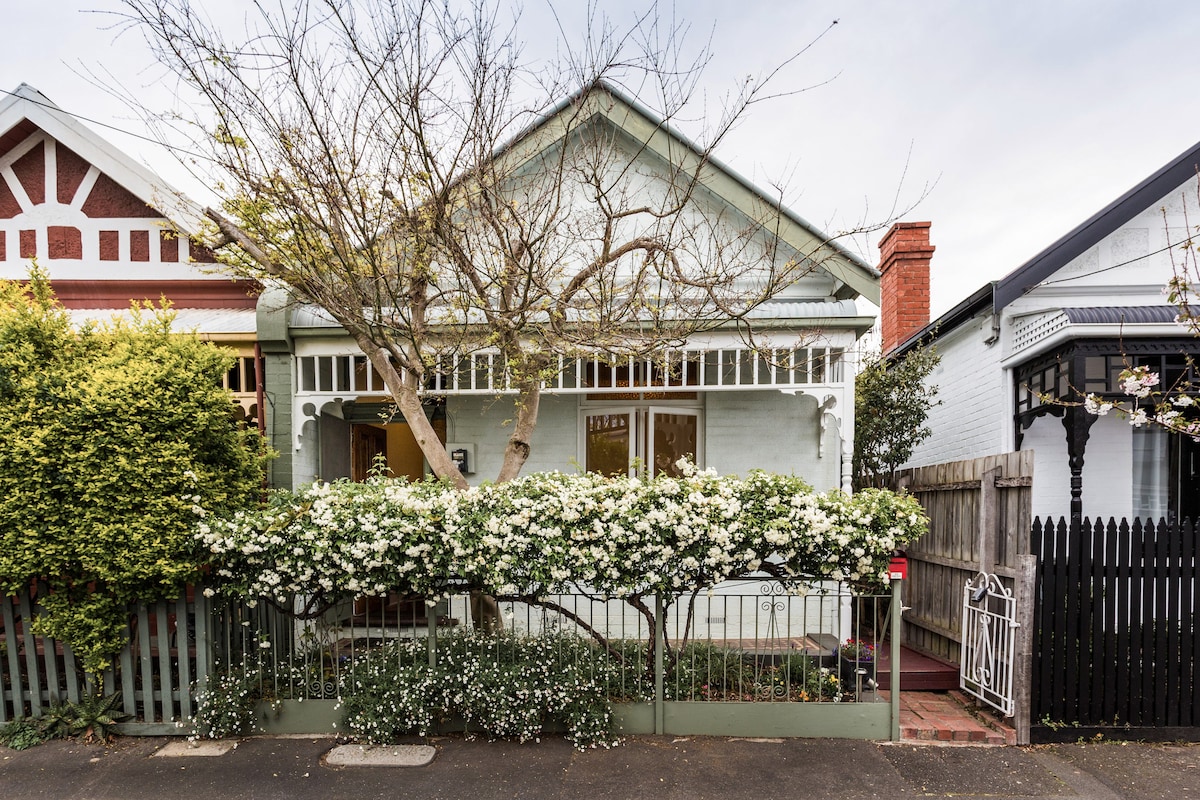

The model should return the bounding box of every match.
[0,83,203,233]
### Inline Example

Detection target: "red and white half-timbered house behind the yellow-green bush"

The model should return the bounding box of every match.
[0,84,259,419]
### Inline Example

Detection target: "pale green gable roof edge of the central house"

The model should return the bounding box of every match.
[496,82,880,305]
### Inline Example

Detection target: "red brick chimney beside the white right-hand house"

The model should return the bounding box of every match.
[880,222,936,355]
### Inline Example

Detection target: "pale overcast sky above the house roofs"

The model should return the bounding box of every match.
[7,0,1200,315]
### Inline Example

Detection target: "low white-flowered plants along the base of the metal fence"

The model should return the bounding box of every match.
[340,633,845,747]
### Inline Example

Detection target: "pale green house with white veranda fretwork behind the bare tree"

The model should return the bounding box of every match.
[258,82,878,491]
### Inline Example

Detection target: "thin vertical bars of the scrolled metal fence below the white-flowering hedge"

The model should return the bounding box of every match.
[214,581,890,702]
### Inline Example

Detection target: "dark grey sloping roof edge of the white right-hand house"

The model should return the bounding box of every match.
[994,143,1200,311]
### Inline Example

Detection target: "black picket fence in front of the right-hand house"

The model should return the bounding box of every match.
[1031,519,1200,740]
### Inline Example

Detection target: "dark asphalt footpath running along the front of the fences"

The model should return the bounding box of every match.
[0,736,1200,800]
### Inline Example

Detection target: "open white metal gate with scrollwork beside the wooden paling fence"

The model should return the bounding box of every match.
[959,572,1020,716]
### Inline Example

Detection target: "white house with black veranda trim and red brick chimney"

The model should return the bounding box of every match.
[881,145,1200,519]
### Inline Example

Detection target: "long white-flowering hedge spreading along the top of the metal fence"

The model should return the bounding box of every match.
[197,464,926,609]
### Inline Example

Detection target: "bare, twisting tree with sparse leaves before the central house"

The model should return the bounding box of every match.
[117,0,859,486]
